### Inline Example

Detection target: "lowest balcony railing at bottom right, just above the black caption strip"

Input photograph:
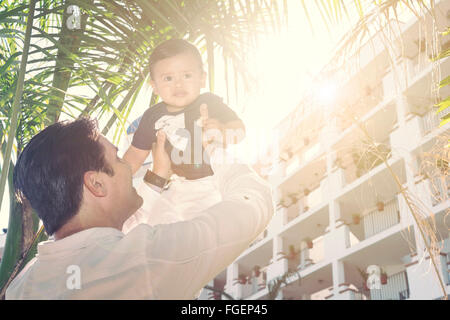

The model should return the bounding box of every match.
[370,271,409,300]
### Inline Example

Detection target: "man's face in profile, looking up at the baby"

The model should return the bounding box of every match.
[99,136,143,227]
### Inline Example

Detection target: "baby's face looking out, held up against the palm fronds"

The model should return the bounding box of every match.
[150,53,206,112]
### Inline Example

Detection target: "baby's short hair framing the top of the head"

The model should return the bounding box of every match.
[149,39,203,79]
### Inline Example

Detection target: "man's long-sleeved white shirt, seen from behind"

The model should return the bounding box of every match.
[6,164,274,299]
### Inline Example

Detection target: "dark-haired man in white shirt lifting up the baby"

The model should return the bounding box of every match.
[6,119,273,299]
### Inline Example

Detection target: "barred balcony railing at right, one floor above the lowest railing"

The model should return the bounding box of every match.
[362,198,400,239]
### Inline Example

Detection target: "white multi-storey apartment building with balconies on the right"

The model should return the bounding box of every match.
[199,1,450,300]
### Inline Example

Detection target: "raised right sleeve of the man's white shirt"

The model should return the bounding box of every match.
[147,164,274,299]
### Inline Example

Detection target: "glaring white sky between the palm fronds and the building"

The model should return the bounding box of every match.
[0,1,354,233]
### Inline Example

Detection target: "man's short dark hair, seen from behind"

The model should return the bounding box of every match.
[13,118,114,235]
